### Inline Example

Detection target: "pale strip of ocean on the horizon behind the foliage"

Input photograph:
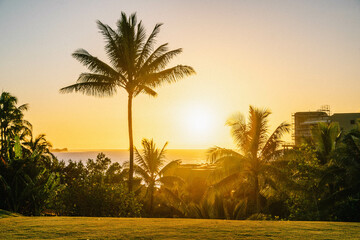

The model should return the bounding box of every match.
[53,149,207,164]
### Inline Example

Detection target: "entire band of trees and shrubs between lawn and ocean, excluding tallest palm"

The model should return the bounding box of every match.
[0,92,360,221]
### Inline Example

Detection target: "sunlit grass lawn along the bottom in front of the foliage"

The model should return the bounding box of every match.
[0,217,360,240]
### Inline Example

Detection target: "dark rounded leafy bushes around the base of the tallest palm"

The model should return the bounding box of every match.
[53,153,141,217]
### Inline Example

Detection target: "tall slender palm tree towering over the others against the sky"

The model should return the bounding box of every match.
[60,12,195,191]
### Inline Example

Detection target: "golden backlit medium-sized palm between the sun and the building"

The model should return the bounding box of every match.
[209,106,290,213]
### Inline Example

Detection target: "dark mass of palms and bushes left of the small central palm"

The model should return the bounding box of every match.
[0,92,141,217]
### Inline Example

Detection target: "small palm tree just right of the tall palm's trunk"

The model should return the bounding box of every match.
[135,139,181,214]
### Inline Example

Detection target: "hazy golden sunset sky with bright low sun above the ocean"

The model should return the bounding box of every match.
[0,0,360,149]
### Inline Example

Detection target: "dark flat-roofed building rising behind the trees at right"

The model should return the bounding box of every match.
[292,105,360,146]
